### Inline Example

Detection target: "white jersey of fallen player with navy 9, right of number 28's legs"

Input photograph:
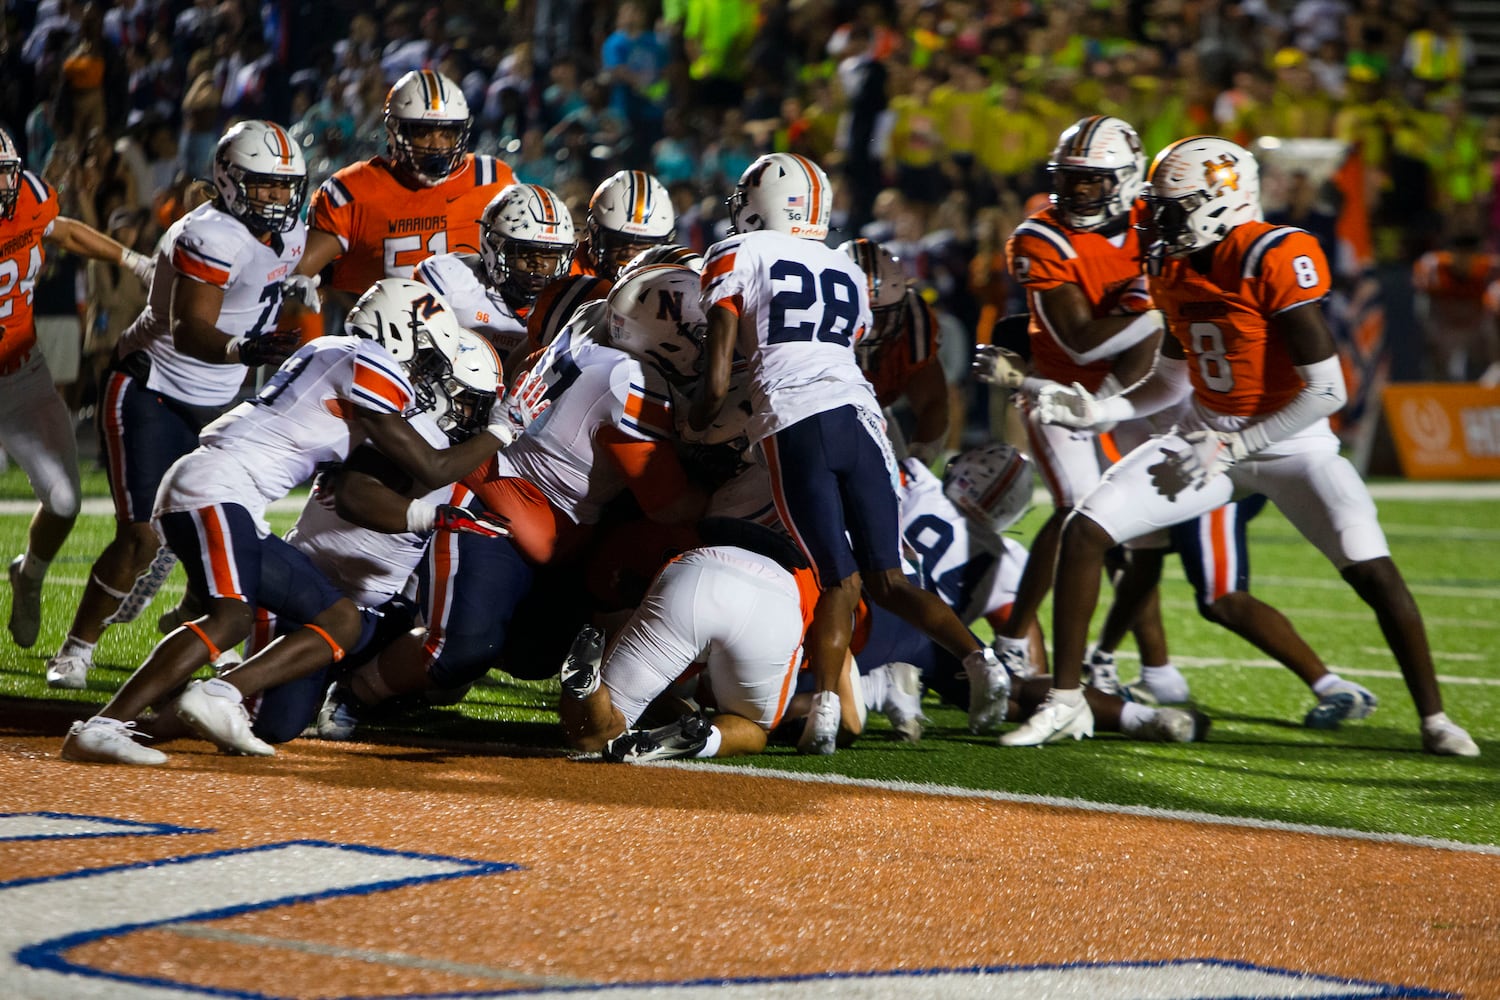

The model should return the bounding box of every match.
[900,459,1028,625]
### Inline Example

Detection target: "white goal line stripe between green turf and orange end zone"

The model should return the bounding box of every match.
[660,761,1500,856]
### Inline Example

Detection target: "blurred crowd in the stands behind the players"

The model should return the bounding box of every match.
[0,0,1500,440]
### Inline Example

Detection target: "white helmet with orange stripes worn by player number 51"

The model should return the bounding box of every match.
[386,69,474,187]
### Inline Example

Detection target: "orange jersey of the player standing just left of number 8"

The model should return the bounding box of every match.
[1005,205,1143,391]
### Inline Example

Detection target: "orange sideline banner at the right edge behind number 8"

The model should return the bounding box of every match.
[1385,382,1500,480]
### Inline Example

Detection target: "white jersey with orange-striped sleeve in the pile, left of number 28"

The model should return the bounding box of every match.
[495,346,674,525]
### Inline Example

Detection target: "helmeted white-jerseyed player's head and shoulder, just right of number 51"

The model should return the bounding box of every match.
[414,184,578,364]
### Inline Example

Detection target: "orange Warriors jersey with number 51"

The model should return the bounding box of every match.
[308,153,516,295]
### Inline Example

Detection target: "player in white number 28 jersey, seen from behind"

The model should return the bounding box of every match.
[692,153,1007,753]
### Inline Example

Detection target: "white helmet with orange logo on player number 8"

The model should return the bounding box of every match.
[1142,135,1262,256]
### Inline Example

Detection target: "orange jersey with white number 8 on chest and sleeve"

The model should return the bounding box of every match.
[1151,222,1331,417]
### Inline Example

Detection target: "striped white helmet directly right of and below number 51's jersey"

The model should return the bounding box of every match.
[479,184,578,307]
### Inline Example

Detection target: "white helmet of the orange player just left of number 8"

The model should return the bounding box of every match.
[1047,114,1146,231]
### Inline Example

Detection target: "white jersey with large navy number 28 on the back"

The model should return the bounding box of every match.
[702,232,881,442]
